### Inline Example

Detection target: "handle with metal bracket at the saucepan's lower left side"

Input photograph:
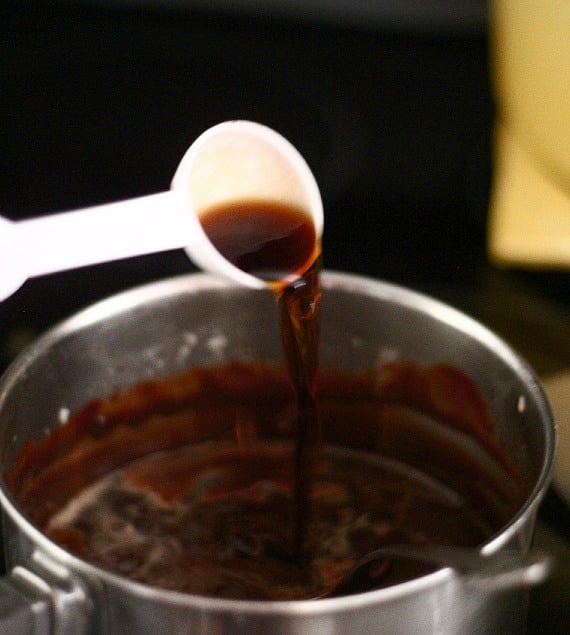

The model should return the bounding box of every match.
[0,551,91,635]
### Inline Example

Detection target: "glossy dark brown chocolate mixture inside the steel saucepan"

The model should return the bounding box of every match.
[6,363,521,599]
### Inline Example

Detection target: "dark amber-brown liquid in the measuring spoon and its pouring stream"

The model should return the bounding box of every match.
[200,201,320,563]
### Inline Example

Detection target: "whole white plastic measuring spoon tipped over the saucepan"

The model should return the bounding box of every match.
[0,121,323,301]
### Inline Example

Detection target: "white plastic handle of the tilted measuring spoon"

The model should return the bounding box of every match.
[0,190,192,300]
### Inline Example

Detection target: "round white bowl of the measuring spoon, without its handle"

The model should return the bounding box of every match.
[172,121,323,288]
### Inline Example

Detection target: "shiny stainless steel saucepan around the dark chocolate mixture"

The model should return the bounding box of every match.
[0,271,555,635]
